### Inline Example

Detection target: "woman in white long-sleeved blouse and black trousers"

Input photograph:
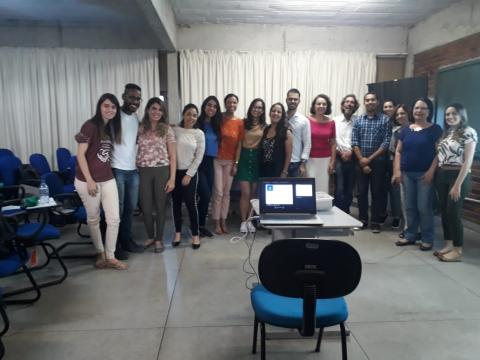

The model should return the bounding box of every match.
[172,104,205,250]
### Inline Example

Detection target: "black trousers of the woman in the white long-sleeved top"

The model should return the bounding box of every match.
[172,170,198,236]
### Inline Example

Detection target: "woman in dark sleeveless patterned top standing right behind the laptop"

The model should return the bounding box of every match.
[260,103,293,177]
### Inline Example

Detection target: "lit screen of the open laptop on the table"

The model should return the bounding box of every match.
[259,178,317,214]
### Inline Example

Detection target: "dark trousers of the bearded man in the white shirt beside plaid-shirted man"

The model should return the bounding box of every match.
[333,158,356,214]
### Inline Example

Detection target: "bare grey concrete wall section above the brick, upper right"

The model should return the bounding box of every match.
[405,0,480,76]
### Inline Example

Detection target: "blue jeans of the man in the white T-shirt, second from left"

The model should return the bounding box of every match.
[113,169,140,246]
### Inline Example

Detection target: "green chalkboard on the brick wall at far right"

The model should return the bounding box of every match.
[436,59,480,159]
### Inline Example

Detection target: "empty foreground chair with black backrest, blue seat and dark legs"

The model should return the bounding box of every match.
[251,239,362,360]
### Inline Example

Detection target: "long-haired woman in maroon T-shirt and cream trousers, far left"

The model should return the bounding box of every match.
[75,93,128,270]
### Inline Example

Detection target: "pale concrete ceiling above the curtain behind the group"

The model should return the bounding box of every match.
[170,0,459,27]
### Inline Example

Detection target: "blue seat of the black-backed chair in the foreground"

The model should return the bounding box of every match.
[251,285,348,329]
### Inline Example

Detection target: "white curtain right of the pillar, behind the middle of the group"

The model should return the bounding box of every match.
[180,50,376,119]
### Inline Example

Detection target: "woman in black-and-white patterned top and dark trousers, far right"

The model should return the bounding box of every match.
[434,104,478,262]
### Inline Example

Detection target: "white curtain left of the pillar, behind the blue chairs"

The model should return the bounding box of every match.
[0,47,160,168]
